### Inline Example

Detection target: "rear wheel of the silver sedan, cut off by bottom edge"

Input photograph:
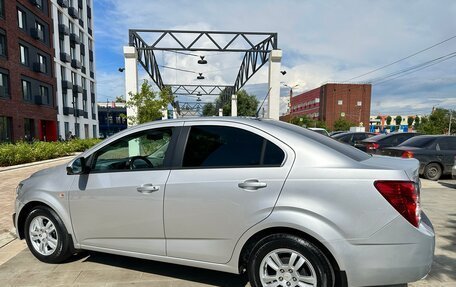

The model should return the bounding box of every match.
[247,234,334,287]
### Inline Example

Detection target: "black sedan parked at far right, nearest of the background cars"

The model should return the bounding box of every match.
[382,136,456,180]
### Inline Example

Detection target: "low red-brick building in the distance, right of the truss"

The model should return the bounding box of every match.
[284,83,372,128]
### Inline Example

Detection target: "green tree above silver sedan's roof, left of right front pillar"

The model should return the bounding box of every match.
[215,89,258,117]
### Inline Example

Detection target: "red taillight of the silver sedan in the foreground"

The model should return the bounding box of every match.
[374,180,421,227]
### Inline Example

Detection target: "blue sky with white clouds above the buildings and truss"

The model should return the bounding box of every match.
[94,0,456,115]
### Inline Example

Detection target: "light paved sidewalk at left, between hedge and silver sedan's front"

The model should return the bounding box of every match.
[0,156,74,236]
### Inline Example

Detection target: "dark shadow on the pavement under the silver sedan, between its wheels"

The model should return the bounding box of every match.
[78,251,250,287]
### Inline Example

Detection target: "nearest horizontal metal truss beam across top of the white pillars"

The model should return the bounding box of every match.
[129,29,277,52]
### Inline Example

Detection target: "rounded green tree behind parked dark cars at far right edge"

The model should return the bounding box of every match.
[418,108,456,135]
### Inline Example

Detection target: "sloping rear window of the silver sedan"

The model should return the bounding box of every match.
[268,121,371,161]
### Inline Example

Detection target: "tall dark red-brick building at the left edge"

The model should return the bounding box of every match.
[0,0,57,142]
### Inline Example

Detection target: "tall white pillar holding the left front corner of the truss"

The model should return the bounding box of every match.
[124,46,138,127]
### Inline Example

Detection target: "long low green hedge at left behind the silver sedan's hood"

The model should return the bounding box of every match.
[0,139,100,166]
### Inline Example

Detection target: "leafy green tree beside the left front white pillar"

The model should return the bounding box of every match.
[125,80,173,125]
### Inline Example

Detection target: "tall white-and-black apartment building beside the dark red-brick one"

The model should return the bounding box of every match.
[50,0,98,138]
